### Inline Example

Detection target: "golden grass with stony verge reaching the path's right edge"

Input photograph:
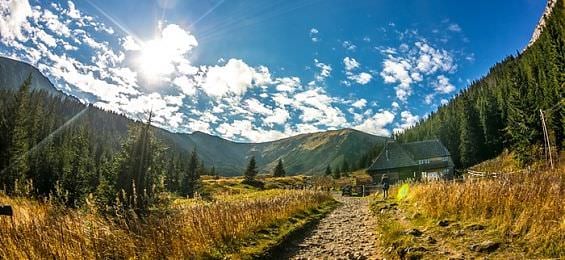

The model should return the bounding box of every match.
[372,169,565,258]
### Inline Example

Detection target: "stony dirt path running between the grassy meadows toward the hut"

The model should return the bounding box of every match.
[286,196,378,259]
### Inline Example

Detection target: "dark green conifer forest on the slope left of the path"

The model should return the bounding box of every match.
[0,78,209,209]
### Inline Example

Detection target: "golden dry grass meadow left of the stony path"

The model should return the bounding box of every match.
[0,190,333,259]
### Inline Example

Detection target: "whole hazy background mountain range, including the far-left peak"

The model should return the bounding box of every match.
[0,57,388,176]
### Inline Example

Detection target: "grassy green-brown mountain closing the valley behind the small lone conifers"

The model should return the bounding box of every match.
[186,129,389,175]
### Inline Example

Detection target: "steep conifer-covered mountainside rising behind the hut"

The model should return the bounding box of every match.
[397,0,565,168]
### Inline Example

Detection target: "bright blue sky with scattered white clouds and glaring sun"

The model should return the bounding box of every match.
[0,0,545,142]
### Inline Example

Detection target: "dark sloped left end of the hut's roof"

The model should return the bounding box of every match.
[369,141,418,171]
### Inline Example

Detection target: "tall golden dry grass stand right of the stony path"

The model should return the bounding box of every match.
[408,168,565,257]
